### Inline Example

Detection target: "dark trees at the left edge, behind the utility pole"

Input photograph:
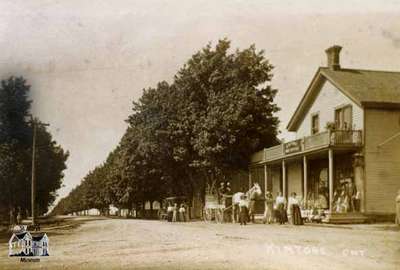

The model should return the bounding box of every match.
[0,77,68,219]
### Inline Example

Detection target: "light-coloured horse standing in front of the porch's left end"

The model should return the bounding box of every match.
[232,183,262,223]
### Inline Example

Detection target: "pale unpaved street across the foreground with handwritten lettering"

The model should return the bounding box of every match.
[0,219,400,270]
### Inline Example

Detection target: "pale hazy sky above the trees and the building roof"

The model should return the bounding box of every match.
[0,0,400,202]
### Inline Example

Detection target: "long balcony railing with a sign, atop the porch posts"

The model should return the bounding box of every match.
[252,130,362,162]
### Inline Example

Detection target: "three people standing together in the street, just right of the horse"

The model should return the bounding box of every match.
[264,191,303,225]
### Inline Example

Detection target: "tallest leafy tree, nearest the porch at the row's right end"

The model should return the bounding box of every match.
[175,40,278,192]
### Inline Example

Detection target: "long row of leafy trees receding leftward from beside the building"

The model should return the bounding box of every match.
[54,39,278,214]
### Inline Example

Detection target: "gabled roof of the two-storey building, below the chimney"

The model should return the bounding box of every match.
[287,67,400,131]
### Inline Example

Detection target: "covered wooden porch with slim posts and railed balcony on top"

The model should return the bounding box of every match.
[249,131,366,223]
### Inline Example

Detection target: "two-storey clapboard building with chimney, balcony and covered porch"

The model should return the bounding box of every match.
[249,46,400,223]
